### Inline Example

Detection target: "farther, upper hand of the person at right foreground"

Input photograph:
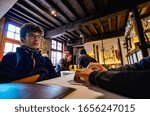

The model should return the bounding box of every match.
[87,62,107,72]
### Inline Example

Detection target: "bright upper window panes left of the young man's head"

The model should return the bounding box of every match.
[6,24,20,41]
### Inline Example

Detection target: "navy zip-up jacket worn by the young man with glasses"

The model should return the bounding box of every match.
[0,46,58,83]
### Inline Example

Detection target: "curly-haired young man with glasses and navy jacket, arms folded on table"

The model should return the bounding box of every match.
[0,23,58,83]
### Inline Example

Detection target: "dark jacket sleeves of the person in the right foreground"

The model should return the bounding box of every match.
[89,56,150,98]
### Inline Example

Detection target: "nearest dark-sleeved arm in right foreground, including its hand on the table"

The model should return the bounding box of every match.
[74,69,150,98]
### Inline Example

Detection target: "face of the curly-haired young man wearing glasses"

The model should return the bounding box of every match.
[23,32,42,49]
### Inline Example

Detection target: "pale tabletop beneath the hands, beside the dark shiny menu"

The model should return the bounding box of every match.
[38,74,126,99]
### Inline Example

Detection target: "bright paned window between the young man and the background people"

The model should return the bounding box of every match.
[51,40,63,66]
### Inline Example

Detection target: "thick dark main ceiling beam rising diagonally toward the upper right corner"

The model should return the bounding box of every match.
[46,0,149,37]
